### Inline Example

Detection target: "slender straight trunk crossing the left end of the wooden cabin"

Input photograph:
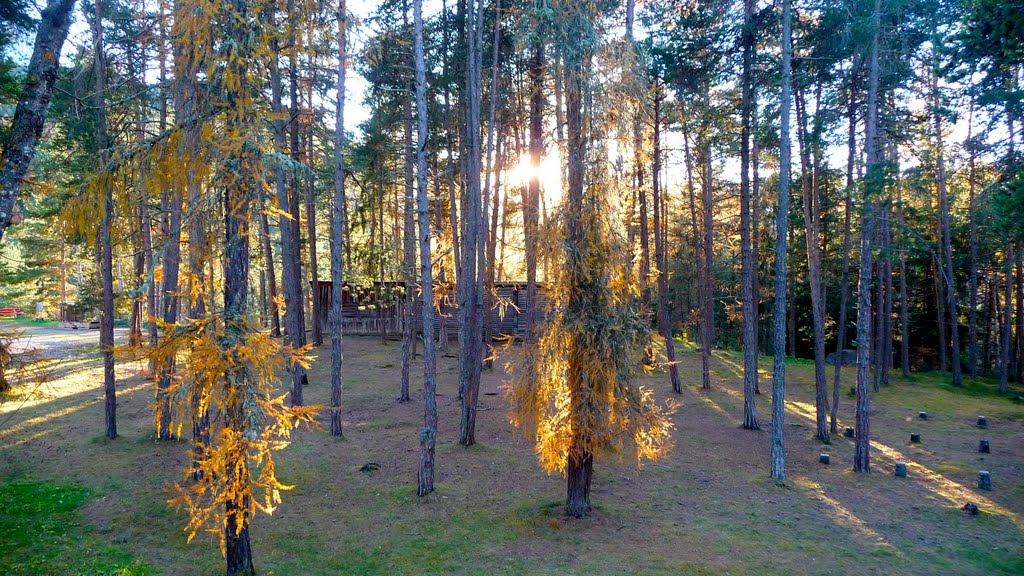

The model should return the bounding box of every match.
[330,0,350,436]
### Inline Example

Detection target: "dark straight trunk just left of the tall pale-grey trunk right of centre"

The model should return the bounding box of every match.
[739,0,761,430]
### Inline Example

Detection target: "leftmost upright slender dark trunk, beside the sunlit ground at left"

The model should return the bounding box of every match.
[93,1,118,440]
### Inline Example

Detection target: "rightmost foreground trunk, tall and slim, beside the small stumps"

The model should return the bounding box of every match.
[853,0,882,472]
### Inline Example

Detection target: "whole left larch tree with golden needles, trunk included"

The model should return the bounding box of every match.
[142,0,316,576]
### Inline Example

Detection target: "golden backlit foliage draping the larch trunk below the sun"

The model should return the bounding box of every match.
[506,175,673,474]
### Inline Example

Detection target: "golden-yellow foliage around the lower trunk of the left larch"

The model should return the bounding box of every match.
[150,316,321,548]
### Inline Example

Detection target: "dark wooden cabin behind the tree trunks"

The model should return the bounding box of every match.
[316,280,547,338]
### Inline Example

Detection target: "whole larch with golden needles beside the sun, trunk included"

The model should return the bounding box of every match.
[507,0,672,518]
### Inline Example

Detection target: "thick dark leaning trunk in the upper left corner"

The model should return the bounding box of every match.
[0,0,75,240]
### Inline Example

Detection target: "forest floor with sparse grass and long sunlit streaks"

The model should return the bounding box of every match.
[0,330,1024,576]
